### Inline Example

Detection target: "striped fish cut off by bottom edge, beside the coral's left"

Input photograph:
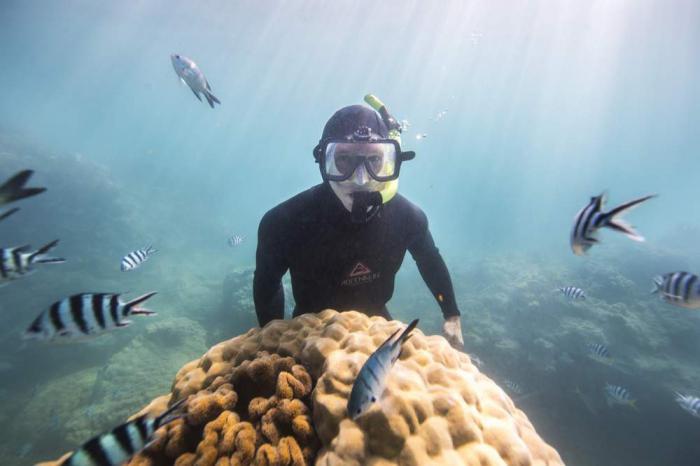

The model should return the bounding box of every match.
[61,399,185,466]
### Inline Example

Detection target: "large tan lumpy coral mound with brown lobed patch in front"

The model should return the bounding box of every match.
[42,310,563,466]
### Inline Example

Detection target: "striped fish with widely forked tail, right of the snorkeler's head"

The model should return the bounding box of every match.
[570,194,654,256]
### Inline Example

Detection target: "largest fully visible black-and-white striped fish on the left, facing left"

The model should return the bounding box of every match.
[24,291,156,340]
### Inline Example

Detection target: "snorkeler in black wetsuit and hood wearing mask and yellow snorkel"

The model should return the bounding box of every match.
[253,96,464,349]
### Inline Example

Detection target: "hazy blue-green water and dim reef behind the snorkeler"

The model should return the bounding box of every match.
[0,0,700,466]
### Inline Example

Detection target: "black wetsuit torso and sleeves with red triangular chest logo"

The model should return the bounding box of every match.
[253,183,459,326]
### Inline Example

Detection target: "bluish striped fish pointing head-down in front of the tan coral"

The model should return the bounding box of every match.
[348,319,418,420]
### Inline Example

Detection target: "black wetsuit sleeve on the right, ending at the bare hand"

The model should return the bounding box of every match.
[408,212,460,319]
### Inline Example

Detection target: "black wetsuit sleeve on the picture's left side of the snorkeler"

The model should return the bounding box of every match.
[253,212,289,327]
